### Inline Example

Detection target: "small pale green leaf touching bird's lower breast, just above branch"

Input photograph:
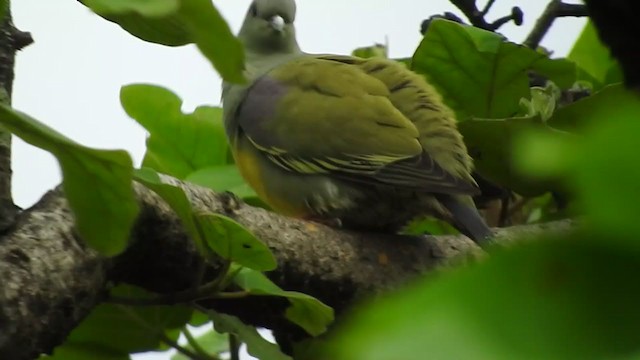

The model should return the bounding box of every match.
[185,165,257,198]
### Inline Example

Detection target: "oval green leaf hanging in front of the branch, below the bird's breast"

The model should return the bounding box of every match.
[193,213,278,271]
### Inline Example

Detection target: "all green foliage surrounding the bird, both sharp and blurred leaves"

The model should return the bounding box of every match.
[0,0,640,359]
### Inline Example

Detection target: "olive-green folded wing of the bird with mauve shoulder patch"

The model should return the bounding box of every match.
[234,57,476,193]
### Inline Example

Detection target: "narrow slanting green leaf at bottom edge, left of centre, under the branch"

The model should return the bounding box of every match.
[208,310,291,360]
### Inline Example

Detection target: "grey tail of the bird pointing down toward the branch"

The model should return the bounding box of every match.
[438,195,493,247]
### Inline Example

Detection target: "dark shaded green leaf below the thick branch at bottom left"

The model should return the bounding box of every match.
[46,285,192,360]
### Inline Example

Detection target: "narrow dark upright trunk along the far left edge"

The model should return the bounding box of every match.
[0,1,33,233]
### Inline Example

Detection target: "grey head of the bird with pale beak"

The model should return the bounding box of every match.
[238,0,299,54]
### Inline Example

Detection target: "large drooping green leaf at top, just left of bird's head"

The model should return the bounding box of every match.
[81,0,245,82]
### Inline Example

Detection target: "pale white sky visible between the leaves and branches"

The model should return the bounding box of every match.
[12,0,585,359]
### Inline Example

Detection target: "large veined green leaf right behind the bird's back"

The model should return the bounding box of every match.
[412,19,576,121]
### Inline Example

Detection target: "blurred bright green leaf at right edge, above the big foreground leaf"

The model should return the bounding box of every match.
[574,91,640,238]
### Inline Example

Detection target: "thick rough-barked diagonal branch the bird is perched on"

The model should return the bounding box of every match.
[0,179,572,360]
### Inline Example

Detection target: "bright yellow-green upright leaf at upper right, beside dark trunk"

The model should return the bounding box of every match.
[568,22,622,90]
